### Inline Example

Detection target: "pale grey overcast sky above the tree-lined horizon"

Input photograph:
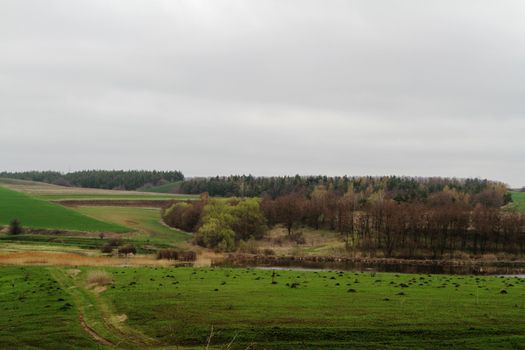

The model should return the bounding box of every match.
[0,0,525,186]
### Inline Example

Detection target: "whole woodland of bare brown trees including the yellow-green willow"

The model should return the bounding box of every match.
[163,178,525,258]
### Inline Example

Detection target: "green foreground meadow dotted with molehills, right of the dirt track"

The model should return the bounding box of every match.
[105,269,525,349]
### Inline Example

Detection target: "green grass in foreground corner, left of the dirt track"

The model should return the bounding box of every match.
[0,267,104,349]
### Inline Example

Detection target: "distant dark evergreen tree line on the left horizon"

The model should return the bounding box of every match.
[0,170,184,190]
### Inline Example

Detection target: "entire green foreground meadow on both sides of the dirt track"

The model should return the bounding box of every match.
[5,267,525,349]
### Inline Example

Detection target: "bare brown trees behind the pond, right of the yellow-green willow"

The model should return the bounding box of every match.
[261,187,525,258]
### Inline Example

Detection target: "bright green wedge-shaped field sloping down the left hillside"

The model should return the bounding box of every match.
[0,187,129,232]
